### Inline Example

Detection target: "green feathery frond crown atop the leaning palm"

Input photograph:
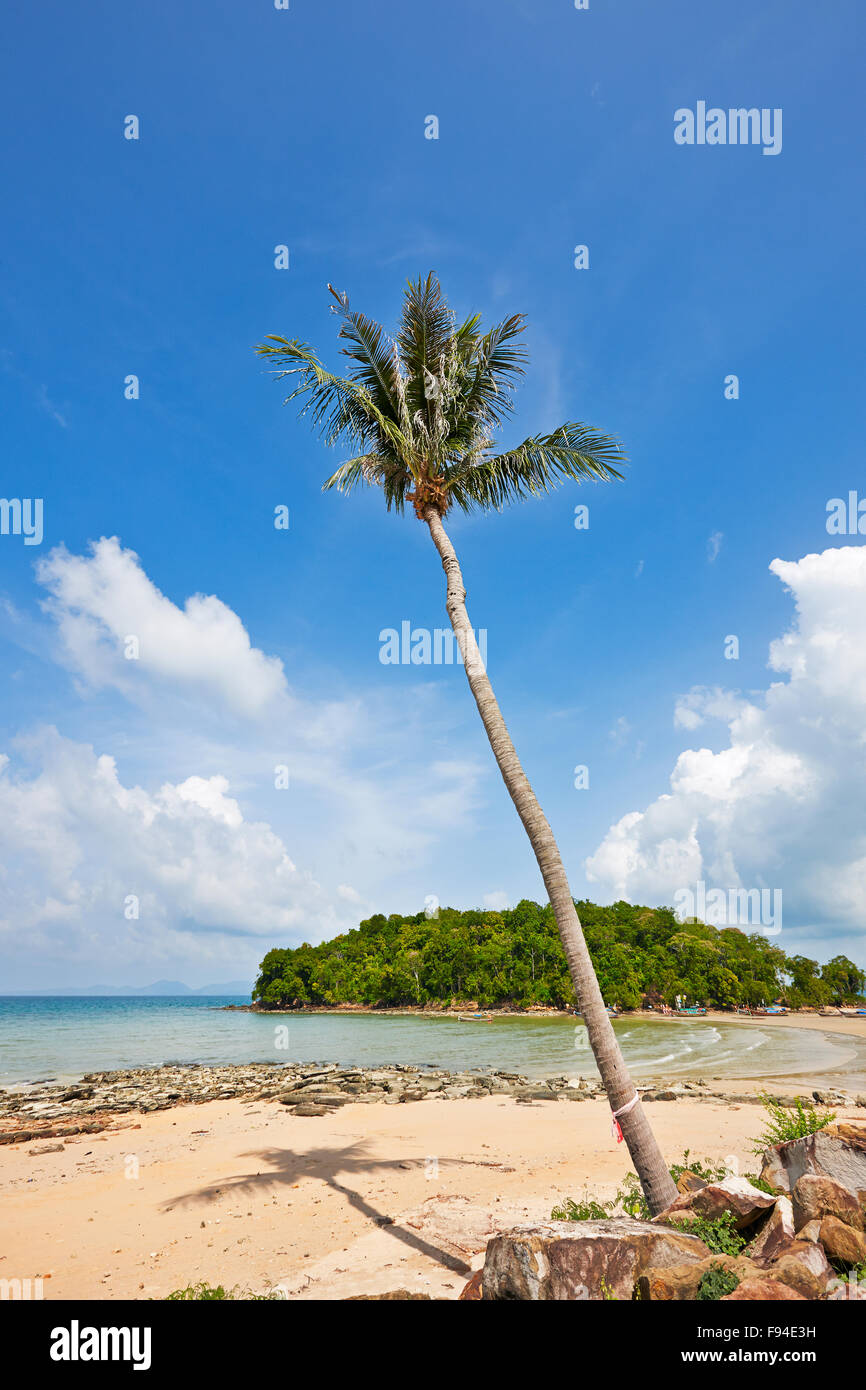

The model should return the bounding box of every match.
[256,274,626,517]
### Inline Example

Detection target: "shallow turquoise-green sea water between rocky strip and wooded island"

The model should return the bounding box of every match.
[0,995,866,1090]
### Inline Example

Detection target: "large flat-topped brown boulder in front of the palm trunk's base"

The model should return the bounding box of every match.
[482,1216,709,1302]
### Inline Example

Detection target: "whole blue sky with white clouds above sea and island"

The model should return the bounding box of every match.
[0,0,866,988]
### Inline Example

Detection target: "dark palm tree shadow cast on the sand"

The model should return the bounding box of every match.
[163,1140,471,1275]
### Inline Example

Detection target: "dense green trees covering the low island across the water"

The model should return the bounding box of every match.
[253,899,866,1009]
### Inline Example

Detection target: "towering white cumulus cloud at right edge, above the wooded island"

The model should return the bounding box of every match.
[585,546,866,933]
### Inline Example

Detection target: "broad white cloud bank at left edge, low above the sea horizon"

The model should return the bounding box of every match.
[0,728,336,965]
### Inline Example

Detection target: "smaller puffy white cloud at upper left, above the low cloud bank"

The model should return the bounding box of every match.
[36,537,286,716]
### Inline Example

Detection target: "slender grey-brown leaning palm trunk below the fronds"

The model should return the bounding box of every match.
[424,507,677,1216]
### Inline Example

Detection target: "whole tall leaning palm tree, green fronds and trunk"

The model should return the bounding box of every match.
[256,275,677,1213]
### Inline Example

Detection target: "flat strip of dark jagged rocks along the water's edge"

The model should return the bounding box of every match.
[0,1062,866,1152]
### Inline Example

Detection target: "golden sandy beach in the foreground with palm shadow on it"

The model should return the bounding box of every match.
[0,1045,863,1300]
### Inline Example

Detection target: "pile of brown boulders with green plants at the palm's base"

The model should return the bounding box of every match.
[475,1123,866,1302]
